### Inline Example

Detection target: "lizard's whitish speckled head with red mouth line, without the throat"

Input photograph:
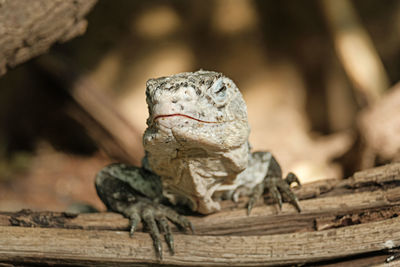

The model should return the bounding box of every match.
[144,70,249,150]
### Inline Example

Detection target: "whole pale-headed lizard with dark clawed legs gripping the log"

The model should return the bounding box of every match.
[95,70,300,259]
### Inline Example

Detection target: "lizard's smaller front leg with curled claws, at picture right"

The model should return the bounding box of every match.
[247,152,301,214]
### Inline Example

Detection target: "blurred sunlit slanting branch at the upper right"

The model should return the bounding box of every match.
[321,0,389,104]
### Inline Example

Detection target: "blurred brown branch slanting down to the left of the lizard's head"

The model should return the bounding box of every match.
[35,56,143,165]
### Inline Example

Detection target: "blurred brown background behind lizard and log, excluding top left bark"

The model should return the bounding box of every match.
[0,0,400,211]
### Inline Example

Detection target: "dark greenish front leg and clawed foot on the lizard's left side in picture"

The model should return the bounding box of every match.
[95,163,193,259]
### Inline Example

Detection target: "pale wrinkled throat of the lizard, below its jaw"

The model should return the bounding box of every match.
[147,142,249,214]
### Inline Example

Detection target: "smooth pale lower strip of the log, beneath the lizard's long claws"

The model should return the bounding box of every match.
[0,218,400,266]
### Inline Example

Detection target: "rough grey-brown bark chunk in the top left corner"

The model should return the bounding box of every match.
[0,0,96,76]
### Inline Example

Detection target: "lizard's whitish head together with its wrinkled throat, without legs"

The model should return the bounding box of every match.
[143,70,250,213]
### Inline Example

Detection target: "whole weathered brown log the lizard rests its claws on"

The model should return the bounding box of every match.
[0,164,400,266]
